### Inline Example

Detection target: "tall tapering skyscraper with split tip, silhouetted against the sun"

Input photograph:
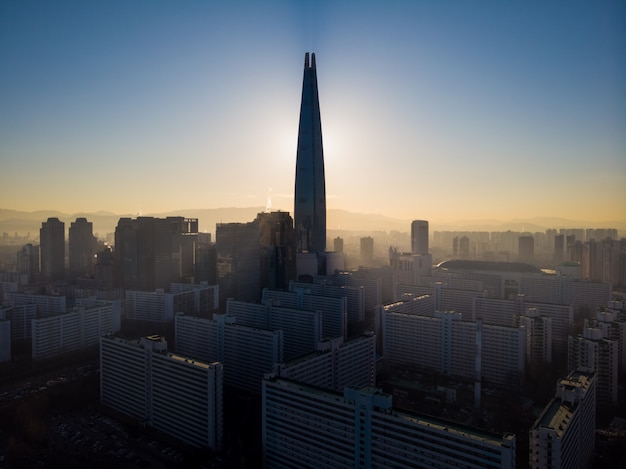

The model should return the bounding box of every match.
[294,52,326,253]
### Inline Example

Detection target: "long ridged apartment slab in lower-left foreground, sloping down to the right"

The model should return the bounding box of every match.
[100,336,224,451]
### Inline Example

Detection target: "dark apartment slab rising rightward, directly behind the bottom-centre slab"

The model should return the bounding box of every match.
[274,333,376,392]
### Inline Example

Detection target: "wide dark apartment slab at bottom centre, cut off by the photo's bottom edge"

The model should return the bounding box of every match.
[262,377,515,469]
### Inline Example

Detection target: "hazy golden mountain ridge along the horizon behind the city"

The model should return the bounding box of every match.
[0,207,626,238]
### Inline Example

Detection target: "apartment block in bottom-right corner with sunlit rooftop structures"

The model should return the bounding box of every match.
[529,371,596,469]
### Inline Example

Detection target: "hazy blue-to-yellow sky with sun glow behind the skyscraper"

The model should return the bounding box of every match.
[0,0,626,221]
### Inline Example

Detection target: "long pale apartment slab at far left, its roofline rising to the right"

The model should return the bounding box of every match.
[31,301,121,360]
